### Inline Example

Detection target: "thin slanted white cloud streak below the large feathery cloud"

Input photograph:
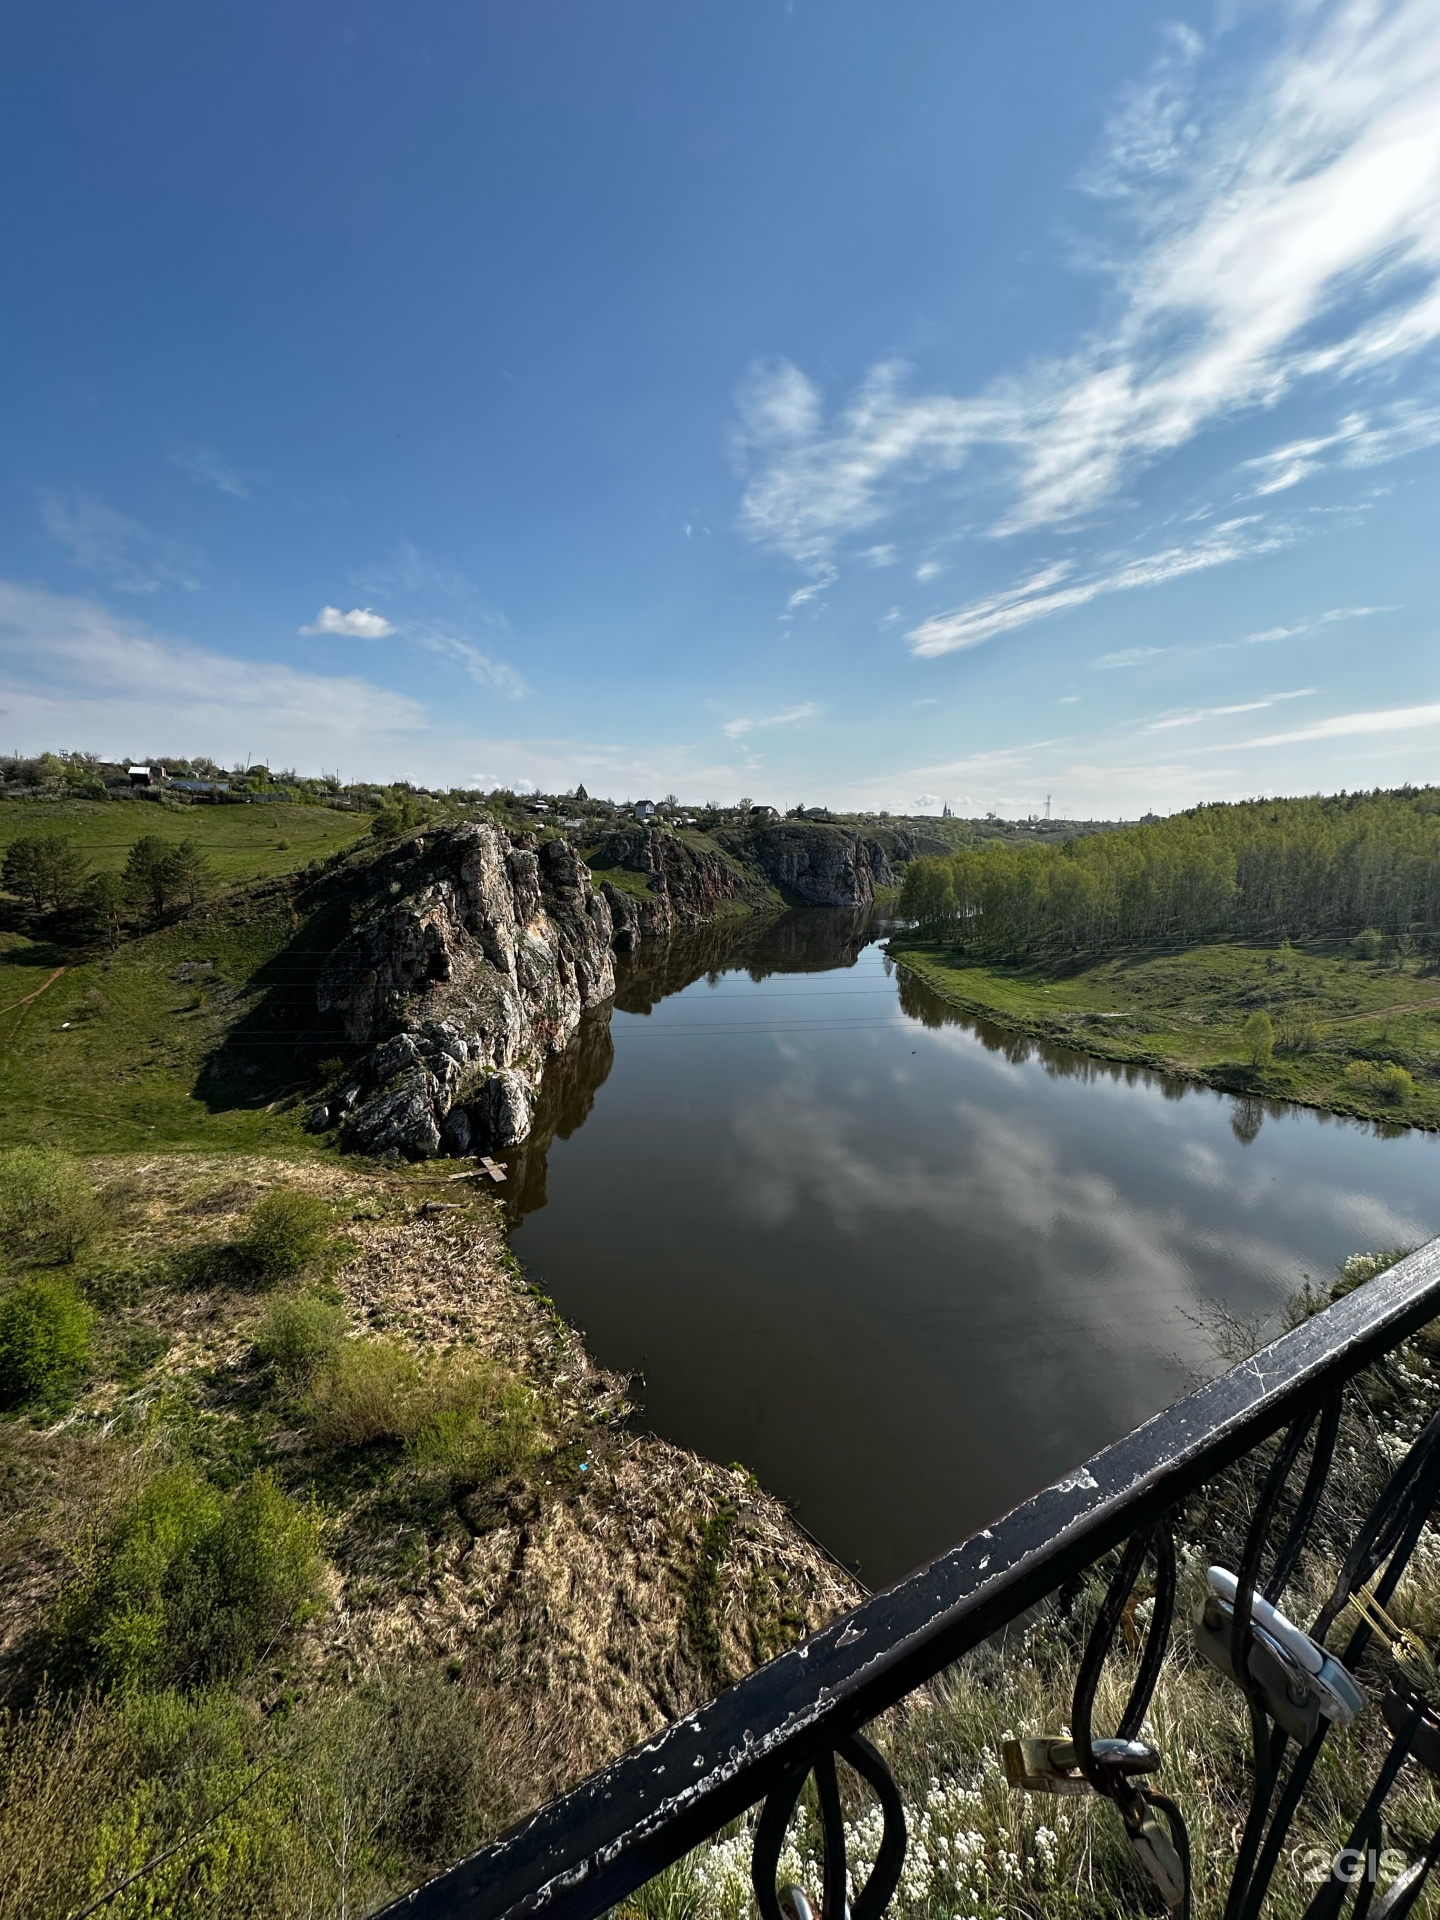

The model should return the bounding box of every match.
[904,515,1294,664]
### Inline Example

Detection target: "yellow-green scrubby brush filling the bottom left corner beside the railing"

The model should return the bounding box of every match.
[0,1663,506,1920]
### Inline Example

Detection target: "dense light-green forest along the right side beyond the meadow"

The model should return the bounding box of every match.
[899,787,1440,956]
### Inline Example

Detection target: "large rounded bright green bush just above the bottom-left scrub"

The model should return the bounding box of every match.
[54,1467,323,1688]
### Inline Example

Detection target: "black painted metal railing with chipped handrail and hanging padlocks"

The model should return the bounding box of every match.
[384,1240,1440,1920]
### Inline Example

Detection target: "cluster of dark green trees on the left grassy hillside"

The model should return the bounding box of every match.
[0,833,215,941]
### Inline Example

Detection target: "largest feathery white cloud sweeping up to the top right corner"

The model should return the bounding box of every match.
[737,0,1440,602]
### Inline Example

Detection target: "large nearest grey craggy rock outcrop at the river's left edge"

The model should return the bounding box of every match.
[311,826,614,1158]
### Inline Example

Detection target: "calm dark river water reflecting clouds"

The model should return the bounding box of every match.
[509,912,1440,1586]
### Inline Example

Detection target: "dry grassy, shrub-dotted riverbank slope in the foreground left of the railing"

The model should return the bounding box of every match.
[0,1152,860,1920]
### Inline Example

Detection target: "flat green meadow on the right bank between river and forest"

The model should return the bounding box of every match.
[889,935,1440,1129]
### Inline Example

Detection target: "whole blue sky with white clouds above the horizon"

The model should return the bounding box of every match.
[0,0,1440,816]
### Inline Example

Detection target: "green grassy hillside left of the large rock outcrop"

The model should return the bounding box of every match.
[0,801,378,1152]
